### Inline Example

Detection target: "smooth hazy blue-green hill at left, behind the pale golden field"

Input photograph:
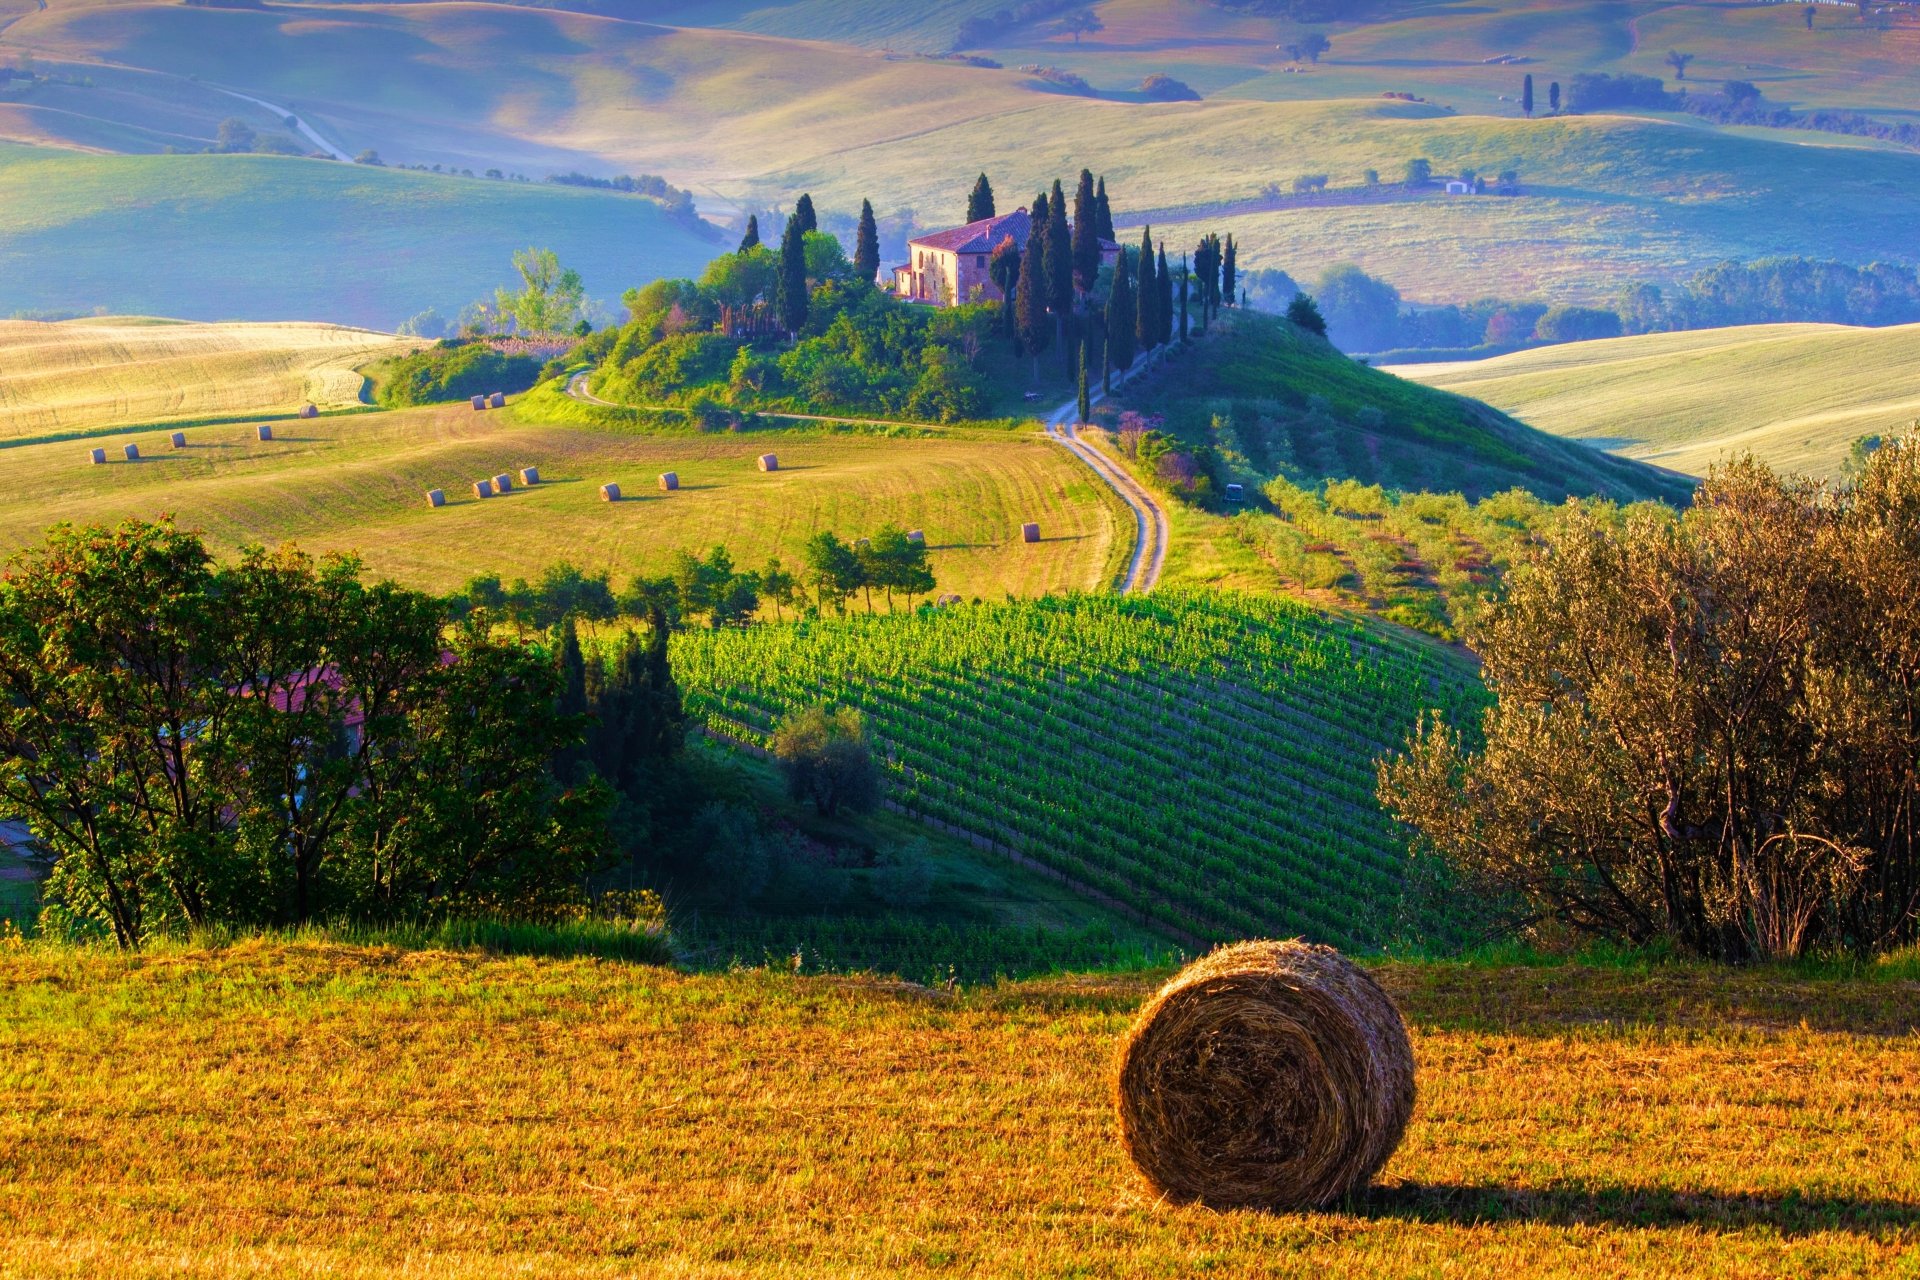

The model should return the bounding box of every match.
[0,144,716,328]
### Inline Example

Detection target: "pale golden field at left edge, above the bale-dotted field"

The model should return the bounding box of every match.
[0,319,419,439]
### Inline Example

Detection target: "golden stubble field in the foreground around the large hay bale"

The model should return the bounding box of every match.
[0,944,1920,1280]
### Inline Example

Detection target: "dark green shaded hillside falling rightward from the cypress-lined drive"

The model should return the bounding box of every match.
[1116,311,1692,501]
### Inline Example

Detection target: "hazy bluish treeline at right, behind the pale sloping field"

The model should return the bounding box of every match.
[1246,257,1920,363]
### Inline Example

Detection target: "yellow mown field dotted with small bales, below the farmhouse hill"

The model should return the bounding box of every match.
[0,403,1133,599]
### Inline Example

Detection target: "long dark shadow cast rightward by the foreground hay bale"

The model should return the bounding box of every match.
[1352,1182,1920,1236]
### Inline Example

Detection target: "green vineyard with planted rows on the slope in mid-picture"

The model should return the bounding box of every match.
[674,593,1482,946]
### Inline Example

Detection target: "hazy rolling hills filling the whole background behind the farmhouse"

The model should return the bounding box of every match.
[0,0,1920,324]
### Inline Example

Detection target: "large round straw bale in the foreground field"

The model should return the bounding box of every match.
[1114,940,1413,1209]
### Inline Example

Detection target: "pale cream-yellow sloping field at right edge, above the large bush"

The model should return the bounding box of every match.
[1398,324,1920,476]
